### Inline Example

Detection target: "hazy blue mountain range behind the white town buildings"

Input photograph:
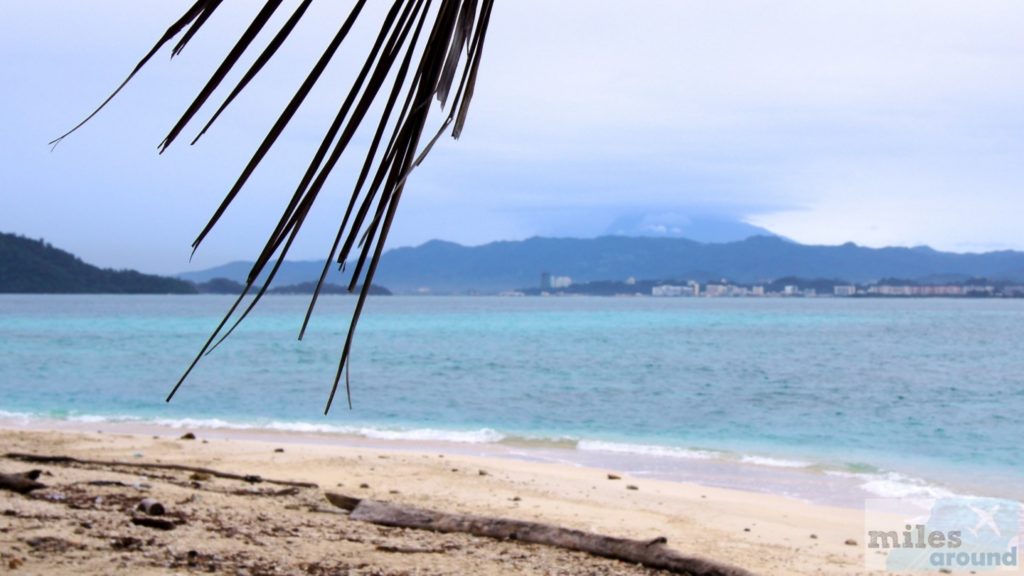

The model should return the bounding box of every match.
[178,236,1024,293]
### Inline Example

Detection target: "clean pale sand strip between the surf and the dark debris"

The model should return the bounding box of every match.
[0,426,888,574]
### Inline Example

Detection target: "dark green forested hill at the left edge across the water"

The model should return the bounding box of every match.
[0,233,196,294]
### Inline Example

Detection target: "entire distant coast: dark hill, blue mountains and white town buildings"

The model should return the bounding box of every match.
[8,227,1024,298]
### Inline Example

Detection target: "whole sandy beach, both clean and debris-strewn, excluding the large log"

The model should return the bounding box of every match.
[0,428,929,575]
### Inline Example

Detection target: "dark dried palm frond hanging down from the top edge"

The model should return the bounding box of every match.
[50,0,494,413]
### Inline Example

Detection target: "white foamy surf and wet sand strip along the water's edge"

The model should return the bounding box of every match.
[0,412,991,509]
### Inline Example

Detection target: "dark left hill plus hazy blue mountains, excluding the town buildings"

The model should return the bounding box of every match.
[8,226,1024,294]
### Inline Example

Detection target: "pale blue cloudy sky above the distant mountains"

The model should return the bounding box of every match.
[0,0,1024,274]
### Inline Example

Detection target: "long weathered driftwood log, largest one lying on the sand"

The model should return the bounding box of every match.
[327,492,753,576]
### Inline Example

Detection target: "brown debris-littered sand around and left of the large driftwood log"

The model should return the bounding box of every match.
[0,453,657,576]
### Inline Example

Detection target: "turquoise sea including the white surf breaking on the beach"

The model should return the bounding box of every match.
[0,295,1024,505]
